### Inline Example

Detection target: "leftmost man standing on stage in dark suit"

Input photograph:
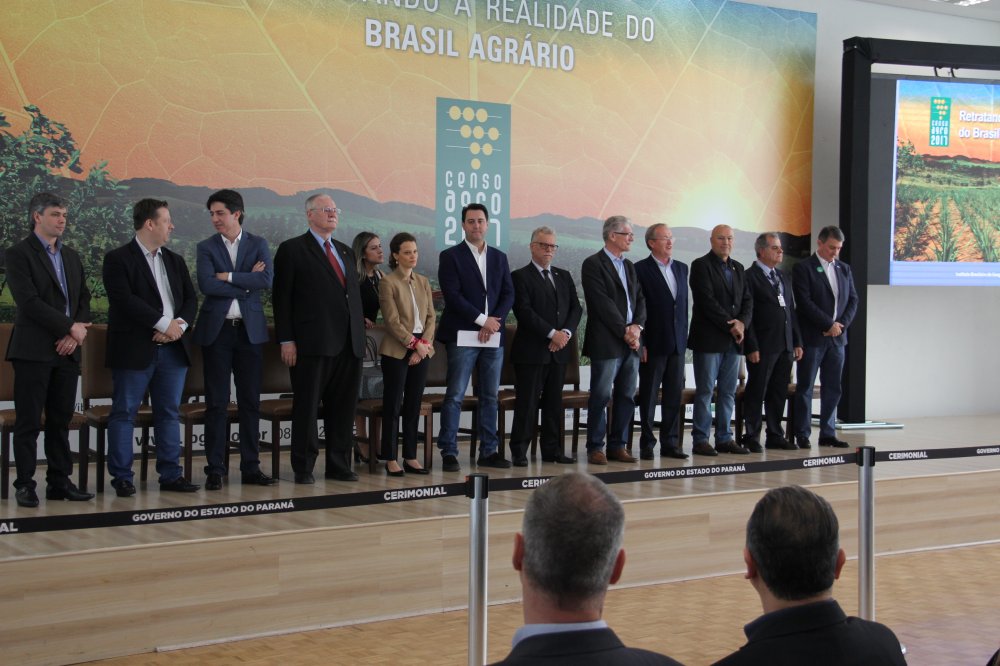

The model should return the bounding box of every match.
[6,192,94,507]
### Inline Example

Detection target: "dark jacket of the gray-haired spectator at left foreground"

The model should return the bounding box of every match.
[496,624,680,666]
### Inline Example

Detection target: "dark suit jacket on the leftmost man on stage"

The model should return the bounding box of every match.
[7,232,90,362]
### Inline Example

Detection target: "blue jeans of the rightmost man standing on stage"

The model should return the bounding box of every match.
[794,338,844,439]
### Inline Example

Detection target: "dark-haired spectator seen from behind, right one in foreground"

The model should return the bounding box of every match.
[716,486,906,666]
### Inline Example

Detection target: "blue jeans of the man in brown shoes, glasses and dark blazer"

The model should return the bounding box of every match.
[587,351,639,453]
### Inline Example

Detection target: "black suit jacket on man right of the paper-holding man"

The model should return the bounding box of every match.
[510,263,583,363]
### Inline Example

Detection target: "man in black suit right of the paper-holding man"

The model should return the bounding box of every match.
[510,227,583,467]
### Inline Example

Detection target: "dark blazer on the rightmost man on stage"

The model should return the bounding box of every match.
[792,254,858,347]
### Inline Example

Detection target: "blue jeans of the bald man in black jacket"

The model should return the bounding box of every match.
[691,351,740,446]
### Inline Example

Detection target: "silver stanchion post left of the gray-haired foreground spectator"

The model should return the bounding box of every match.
[465,474,490,666]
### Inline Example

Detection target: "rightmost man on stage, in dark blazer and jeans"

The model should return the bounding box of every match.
[792,227,858,449]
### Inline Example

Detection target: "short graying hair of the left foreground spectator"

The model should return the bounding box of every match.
[521,472,625,609]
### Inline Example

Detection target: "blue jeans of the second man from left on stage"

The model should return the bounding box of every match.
[108,342,188,483]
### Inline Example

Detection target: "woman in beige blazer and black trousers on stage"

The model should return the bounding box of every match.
[378,232,436,476]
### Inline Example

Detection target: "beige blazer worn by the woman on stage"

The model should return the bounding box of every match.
[378,268,437,358]
